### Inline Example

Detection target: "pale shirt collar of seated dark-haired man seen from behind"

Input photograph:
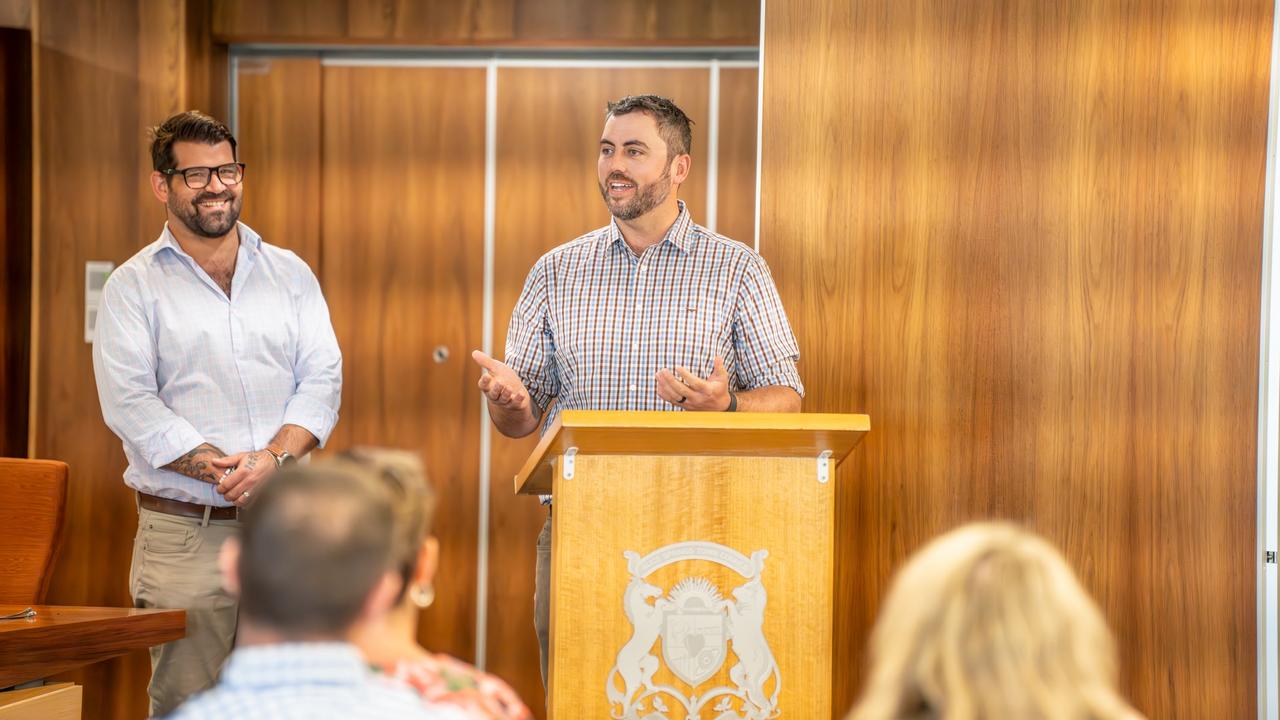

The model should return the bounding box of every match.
[220,642,370,688]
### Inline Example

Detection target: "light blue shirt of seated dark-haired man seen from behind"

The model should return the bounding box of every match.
[169,643,466,720]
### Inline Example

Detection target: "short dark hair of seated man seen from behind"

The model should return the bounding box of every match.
[237,466,394,637]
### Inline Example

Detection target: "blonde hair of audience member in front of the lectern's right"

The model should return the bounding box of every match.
[847,523,1140,720]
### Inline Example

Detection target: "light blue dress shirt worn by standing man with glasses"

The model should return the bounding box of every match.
[93,223,342,506]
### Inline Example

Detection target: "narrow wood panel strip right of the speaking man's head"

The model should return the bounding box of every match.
[716,68,759,245]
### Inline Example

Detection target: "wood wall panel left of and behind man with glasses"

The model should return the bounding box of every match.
[31,0,183,720]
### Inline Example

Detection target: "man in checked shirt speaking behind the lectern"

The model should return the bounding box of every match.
[472,95,804,684]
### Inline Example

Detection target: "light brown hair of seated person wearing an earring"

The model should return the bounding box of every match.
[330,446,435,596]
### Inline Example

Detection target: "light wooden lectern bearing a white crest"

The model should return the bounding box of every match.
[516,410,870,720]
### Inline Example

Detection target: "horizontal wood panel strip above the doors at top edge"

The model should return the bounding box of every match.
[212,0,760,47]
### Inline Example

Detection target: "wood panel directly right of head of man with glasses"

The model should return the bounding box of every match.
[236,58,321,273]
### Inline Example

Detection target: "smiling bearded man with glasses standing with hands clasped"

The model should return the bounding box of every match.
[93,111,342,715]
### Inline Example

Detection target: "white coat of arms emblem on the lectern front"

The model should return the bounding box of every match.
[605,541,782,720]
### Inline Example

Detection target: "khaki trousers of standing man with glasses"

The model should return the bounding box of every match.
[129,509,239,716]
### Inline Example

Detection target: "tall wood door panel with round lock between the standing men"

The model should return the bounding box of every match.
[321,68,485,659]
